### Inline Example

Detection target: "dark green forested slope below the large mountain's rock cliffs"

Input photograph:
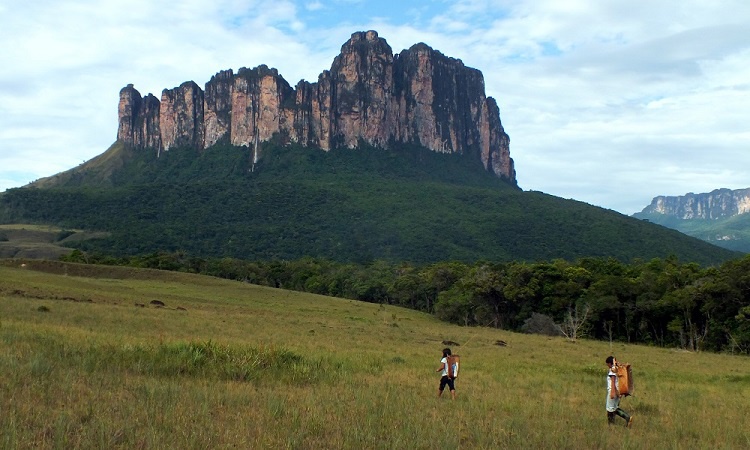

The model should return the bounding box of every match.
[0,143,737,264]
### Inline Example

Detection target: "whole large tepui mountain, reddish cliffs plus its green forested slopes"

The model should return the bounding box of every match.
[0,31,736,264]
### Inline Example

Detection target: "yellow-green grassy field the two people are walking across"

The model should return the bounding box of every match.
[0,260,750,449]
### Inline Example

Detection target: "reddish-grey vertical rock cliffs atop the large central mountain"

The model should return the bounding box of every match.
[117,31,516,184]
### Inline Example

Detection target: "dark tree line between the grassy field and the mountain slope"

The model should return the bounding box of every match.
[63,250,750,354]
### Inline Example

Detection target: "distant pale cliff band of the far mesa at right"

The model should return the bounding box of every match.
[640,188,750,220]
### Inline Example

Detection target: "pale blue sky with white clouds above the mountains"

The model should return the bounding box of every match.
[0,0,750,215]
